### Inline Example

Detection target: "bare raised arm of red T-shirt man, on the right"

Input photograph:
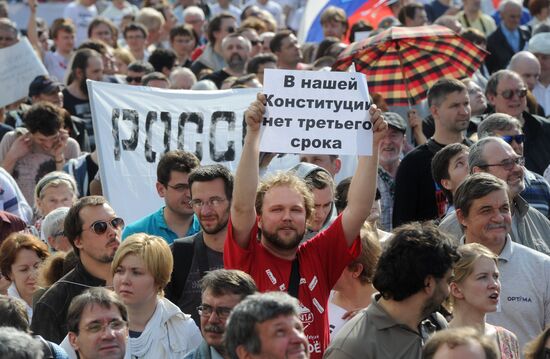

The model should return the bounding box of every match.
[342,105,388,246]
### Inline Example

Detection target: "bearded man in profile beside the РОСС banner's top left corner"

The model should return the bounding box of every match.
[63,49,103,151]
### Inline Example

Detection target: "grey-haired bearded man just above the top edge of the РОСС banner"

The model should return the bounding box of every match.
[204,33,251,88]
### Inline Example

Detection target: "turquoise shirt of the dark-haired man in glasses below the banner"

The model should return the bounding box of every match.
[122,207,201,244]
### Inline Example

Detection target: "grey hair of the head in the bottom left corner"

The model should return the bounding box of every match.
[0,327,44,359]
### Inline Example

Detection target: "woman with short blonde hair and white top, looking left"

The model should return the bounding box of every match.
[111,233,202,359]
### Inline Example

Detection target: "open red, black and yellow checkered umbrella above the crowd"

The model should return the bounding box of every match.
[333,25,488,106]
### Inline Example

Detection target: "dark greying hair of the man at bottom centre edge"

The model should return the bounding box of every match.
[224,292,300,359]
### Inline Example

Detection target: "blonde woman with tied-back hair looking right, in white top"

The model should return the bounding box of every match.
[449,243,520,359]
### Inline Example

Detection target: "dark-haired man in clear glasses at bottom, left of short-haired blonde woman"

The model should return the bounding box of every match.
[67,288,128,359]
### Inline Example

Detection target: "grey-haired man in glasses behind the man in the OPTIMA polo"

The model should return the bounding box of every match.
[439,137,550,254]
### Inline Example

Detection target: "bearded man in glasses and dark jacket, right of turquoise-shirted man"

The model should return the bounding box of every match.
[165,164,233,325]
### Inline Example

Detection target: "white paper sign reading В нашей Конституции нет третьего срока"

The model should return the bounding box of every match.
[260,69,372,155]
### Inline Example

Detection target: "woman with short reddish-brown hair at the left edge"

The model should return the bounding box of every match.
[0,233,50,322]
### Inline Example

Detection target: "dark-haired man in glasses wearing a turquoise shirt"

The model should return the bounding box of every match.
[122,150,200,244]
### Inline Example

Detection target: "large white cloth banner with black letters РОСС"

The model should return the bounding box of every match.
[88,81,258,223]
